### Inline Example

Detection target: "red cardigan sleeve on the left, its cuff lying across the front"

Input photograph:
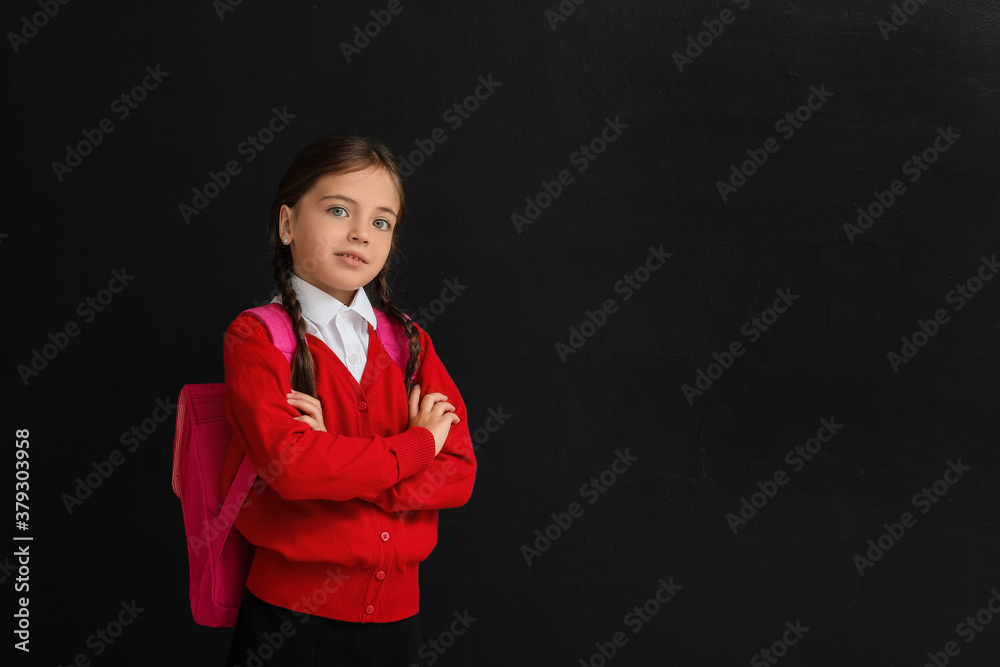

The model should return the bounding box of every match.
[223,317,434,500]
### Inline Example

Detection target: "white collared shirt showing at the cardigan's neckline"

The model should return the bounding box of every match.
[271,273,378,384]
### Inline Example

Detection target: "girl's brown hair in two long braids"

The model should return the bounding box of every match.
[268,134,420,396]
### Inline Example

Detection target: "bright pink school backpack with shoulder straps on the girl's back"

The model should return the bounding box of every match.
[172,303,409,628]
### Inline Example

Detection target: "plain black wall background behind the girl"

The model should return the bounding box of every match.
[0,0,1000,667]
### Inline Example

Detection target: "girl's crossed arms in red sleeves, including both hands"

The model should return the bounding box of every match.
[225,316,476,512]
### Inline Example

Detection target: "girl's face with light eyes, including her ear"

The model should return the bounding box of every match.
[278,168,400,305]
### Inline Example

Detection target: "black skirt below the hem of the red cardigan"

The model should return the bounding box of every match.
[226,591,422,667]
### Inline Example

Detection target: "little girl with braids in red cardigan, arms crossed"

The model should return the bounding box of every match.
[223,135,476,667]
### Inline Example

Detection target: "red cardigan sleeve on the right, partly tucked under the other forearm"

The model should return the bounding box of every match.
[371,327,476,512]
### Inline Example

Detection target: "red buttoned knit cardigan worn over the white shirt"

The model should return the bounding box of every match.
[223,315,476,623]
